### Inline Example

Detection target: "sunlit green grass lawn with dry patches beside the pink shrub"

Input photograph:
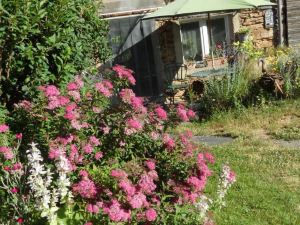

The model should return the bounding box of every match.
[177,100,300,225]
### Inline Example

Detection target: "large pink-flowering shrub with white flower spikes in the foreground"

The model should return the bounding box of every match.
[0,66,235,225]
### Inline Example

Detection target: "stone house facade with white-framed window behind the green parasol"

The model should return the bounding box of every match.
[102,0,279,96]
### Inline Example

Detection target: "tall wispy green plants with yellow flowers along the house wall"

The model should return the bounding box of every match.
[200,45,300,114]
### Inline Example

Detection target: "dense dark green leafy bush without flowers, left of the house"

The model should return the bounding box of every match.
[0,0,110,106]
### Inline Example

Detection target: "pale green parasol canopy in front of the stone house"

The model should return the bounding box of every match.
[143,0,276,19]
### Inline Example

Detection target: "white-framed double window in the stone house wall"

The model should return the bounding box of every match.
[181,17,229,62]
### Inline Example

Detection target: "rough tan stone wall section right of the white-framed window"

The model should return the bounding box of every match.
[235,9,277,48]
